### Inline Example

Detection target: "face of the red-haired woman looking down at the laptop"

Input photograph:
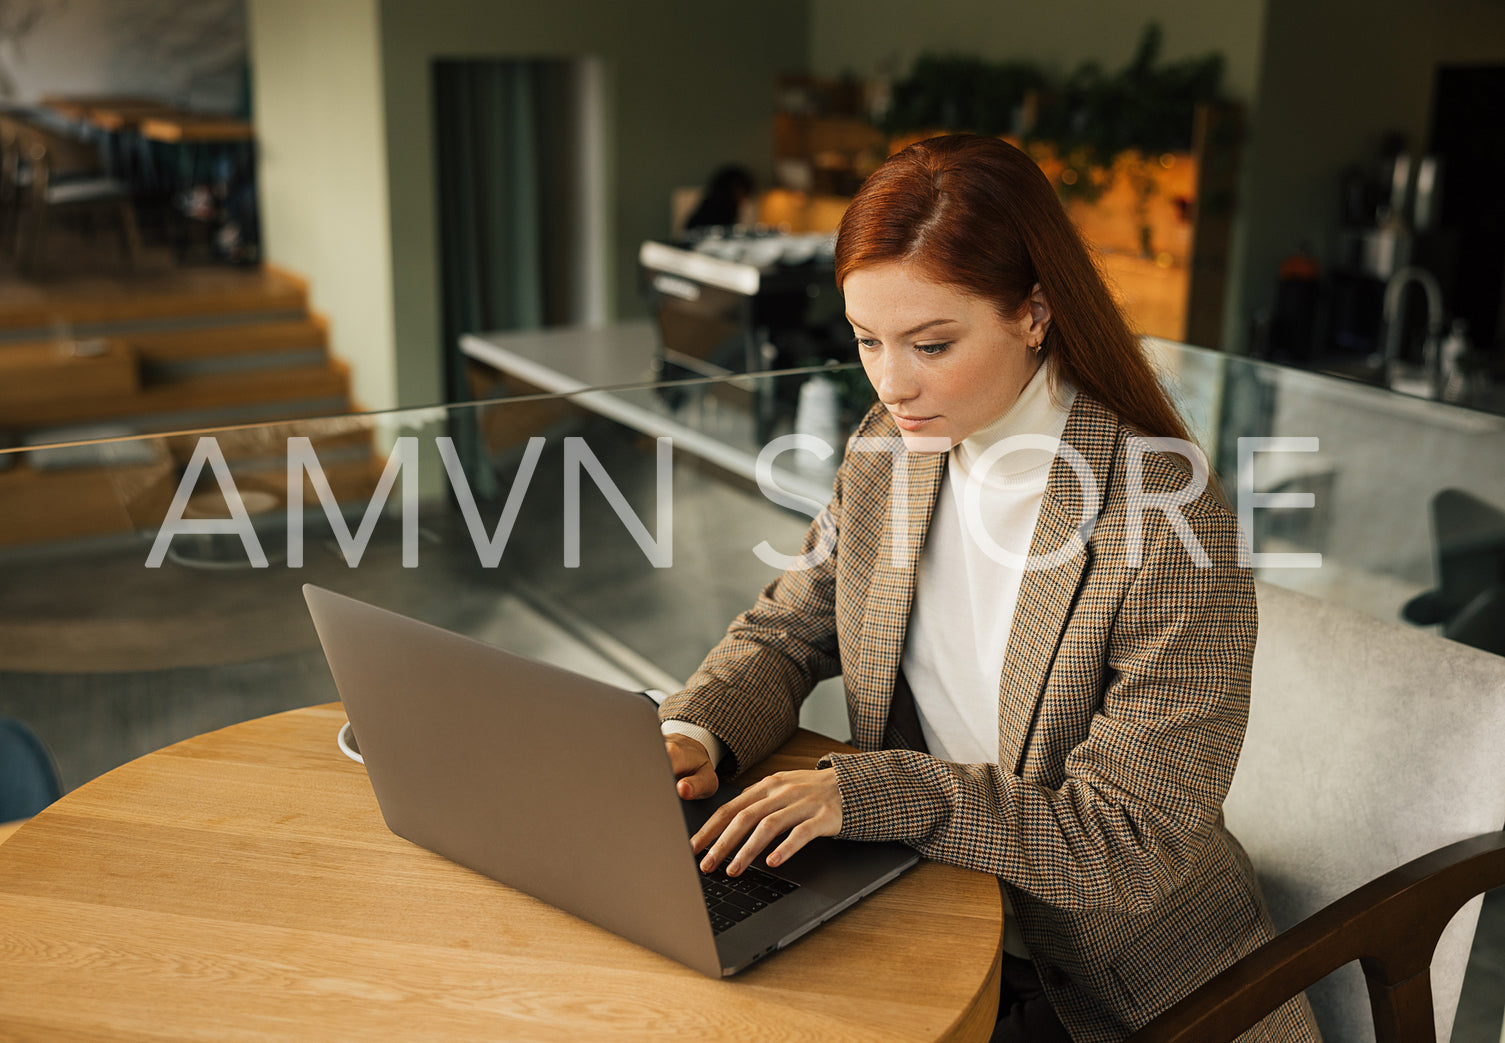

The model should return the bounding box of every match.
[841,262,1050,452]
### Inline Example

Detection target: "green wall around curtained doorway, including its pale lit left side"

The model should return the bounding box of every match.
[250,0,810,409]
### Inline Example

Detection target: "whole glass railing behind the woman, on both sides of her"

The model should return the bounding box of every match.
[0,345,1505,786]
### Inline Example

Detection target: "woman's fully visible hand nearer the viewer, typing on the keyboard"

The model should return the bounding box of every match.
[689,769,841,876]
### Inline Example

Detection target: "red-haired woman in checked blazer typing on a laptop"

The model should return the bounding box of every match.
[664,135,1317,1040]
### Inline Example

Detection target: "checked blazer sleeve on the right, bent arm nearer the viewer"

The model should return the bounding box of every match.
[823,507,1257,912]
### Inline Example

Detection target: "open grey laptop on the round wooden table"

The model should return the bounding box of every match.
[303,585,920,977]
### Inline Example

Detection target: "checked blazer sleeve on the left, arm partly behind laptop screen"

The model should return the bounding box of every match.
[659,458,850,778]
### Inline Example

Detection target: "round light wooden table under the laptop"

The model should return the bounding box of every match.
[0,703,1002,1043]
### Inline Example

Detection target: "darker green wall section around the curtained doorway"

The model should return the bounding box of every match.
[381,0,810,405]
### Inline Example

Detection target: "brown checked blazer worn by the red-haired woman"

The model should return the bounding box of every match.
[662,393,1318,1041]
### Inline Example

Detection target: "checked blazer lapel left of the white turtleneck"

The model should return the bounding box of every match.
[847,452,948,750]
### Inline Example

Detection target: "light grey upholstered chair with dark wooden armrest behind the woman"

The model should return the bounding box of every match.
[1130,584,1505,1043]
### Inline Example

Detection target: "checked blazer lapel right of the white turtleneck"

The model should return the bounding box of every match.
[998,393,1118,774]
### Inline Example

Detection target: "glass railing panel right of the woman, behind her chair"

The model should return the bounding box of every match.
[1151,342,1505,623]
